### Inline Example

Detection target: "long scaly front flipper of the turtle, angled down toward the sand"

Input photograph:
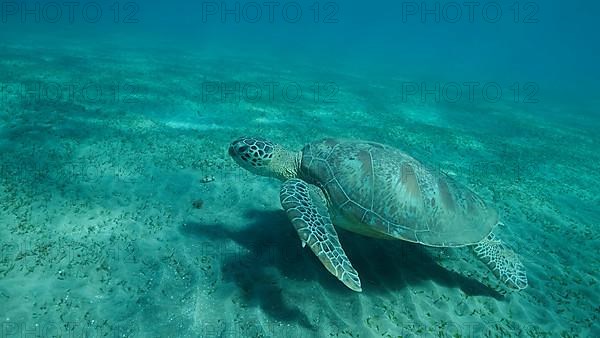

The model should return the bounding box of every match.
[279,178,362,292]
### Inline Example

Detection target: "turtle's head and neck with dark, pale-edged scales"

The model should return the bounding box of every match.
[228,137,298,179]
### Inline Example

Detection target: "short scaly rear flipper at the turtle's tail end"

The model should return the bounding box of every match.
[473,233,527,290]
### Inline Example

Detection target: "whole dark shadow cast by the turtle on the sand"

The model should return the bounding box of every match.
[181,210,503,328]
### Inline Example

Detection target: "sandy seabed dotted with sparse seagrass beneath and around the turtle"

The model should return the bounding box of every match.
[0,40,600,337]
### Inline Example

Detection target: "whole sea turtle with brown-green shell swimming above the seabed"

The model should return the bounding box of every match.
[228,137,527,292]
